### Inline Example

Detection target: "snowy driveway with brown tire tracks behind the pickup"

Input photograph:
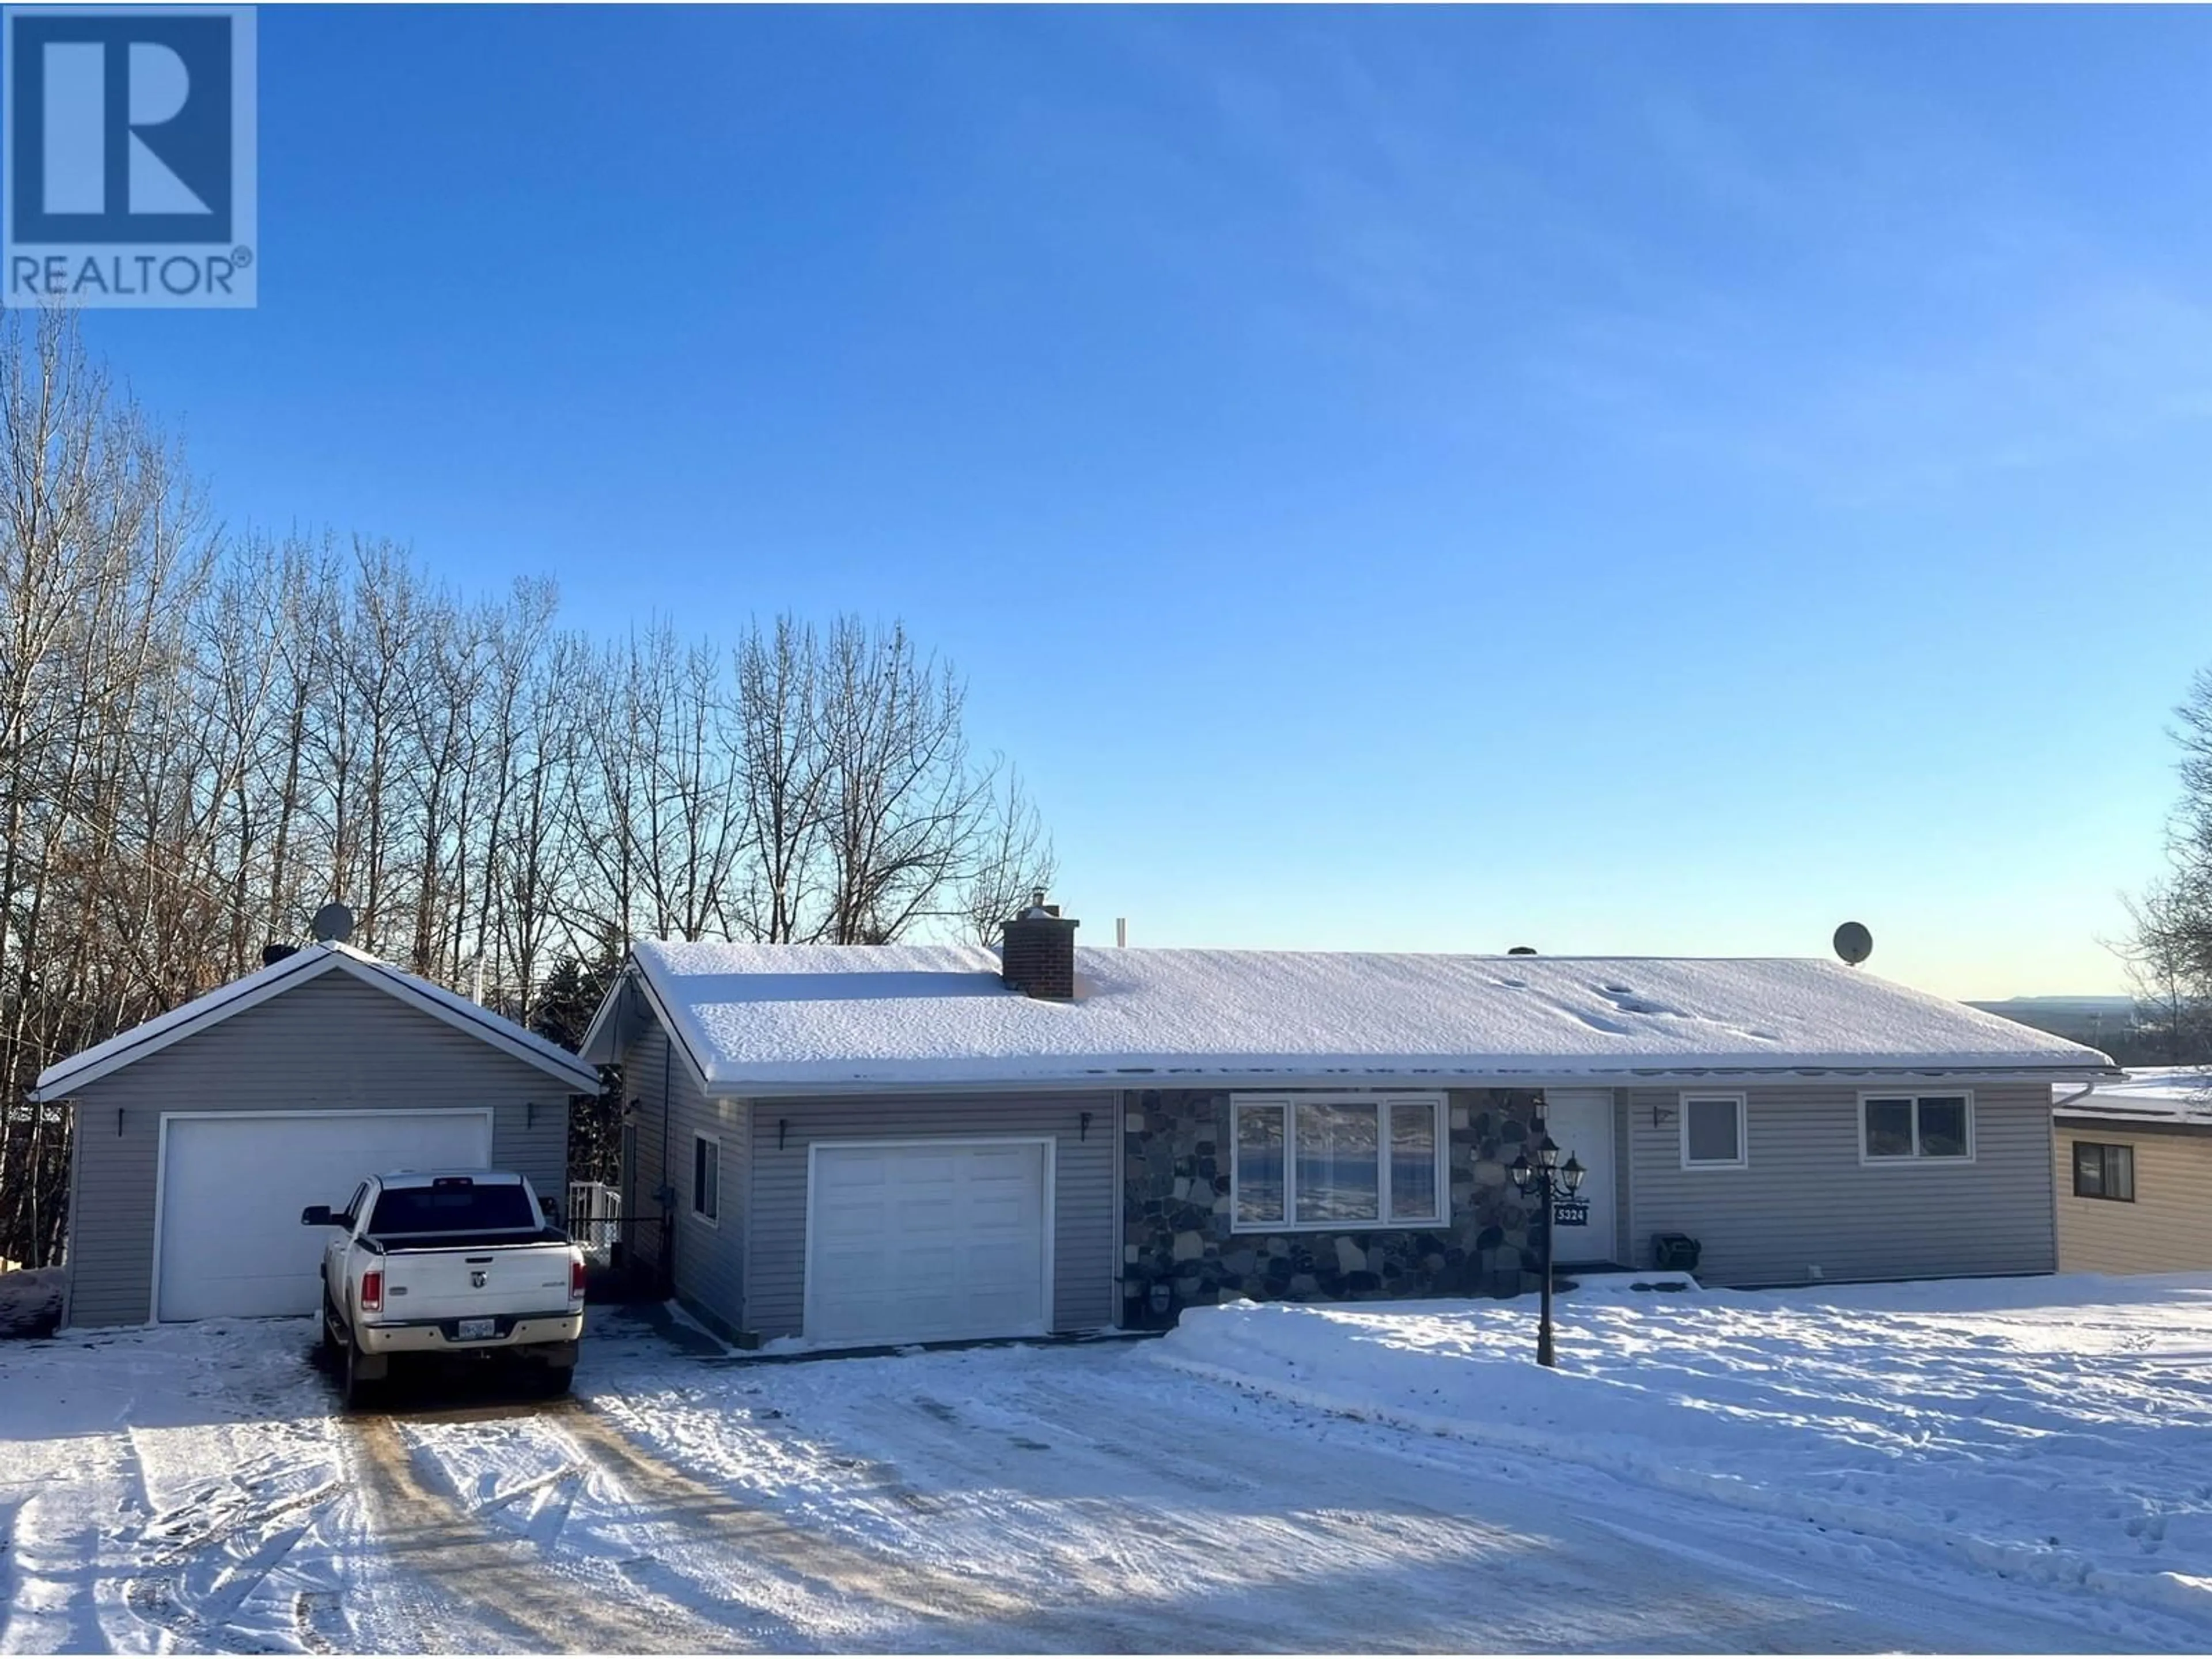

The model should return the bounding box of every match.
[0,1298,2212,1652]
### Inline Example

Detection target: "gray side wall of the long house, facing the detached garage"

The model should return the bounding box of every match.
[622,1013,752,1336]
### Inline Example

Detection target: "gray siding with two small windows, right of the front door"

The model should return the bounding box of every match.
[1626,1084,2057,1285]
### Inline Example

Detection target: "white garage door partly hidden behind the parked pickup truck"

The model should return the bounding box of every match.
[155,1111,491,1319]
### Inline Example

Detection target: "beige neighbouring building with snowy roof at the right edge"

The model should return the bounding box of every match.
[2053,1071,2212,1274]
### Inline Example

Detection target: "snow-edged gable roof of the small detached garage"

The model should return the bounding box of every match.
[31,942,600,1099]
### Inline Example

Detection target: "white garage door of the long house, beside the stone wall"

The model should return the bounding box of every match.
[805,1141,1053,1343]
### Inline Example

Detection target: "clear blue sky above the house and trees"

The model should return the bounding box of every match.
[89,9,2212,995]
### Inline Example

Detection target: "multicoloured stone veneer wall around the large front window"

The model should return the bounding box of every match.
[1122,1088,1537,1327]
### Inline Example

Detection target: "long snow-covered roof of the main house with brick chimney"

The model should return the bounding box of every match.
[584,942,2112,1093]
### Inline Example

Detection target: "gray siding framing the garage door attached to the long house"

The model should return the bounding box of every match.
[745,1093,1122,1340]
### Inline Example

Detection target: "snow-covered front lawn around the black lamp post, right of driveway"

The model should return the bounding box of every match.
[1153,1274,2212,1630]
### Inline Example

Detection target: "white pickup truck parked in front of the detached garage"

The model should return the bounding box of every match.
[298,1170,584,1407]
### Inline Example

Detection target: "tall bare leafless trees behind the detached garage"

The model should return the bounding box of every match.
[0,316,1051,1265]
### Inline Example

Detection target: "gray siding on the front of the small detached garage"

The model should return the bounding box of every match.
[69,971,569,1325]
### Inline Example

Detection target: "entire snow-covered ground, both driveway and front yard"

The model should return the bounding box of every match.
[0,1281,2212,1652]
